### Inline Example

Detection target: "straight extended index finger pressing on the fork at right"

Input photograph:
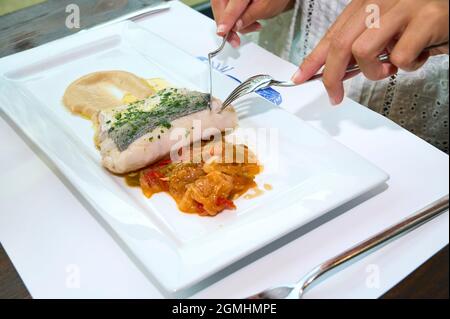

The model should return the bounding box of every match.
[291,1,363,84]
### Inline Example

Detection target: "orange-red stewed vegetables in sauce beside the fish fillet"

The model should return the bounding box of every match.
[125,143,262,216]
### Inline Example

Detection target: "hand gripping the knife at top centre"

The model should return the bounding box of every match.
[211,0,295,48]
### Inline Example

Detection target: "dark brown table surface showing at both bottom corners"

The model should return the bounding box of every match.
[0,245,449,299]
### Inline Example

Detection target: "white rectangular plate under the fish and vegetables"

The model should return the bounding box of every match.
[0,22,388,292]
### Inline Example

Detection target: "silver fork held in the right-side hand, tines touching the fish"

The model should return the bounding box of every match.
[221,42,448,111]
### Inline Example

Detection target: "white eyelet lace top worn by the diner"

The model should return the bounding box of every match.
[248,0,449,153]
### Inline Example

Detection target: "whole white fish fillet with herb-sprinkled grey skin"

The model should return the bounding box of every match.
[96,88,238,174]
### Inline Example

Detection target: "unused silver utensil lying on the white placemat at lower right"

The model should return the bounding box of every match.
[248,195,449,299]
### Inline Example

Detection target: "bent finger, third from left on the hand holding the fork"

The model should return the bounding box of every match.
[352,5,409,81]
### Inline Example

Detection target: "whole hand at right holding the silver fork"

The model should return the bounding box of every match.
[292,0,449,105]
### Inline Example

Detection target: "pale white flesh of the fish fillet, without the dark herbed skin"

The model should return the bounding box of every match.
[96,90,238,174]
